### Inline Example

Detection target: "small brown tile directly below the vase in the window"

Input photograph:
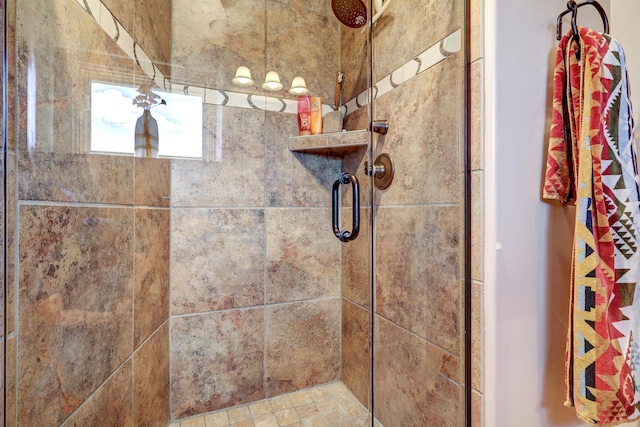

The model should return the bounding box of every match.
[134,157,171,207]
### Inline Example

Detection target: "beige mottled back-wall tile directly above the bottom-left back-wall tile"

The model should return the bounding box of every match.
[171,209,264,314]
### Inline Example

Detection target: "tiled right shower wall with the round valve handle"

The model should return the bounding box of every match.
[343,0,472,426]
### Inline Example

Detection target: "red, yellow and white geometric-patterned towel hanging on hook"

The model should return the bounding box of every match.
[543,28,640,425]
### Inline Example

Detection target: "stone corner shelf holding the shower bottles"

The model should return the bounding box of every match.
[289,130,369,156]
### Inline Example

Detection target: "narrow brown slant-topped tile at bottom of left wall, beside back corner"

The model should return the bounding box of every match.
[133,322,169,426]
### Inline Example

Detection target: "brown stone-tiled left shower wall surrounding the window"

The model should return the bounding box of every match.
[6,0,170,425]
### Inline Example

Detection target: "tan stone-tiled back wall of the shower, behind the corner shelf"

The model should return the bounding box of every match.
[162,0,348,418]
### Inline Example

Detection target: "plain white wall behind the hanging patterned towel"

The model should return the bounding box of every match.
[485,0,640,427]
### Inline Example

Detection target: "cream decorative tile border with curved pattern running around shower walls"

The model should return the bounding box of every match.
[76,0,461,116]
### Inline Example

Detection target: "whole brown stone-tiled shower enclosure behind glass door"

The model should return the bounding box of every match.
[2,0,470,427]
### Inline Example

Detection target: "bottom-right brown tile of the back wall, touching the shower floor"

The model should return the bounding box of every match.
[266,298,340,396]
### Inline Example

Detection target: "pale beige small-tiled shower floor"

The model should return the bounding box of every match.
[169,382,382,427]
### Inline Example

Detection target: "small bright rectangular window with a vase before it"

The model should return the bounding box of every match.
[90,82,202,158]
